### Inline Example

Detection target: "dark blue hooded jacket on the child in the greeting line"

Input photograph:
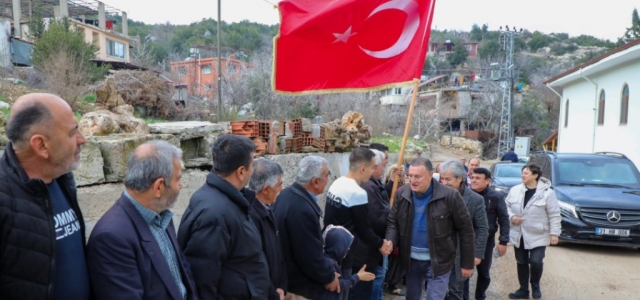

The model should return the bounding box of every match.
[315,225,359,300]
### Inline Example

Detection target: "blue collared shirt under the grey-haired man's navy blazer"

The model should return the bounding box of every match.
[124,191,187,299]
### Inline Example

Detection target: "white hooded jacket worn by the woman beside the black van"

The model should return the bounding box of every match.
[506,177,562,249]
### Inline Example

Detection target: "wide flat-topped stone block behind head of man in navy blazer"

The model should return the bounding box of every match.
[89,134,180,182]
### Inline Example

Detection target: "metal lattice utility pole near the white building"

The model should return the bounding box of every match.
[498,25,522,159]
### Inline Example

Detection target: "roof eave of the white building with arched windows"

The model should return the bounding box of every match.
[544,39,640,86]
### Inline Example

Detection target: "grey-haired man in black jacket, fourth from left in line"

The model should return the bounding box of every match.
[249,158,287,300]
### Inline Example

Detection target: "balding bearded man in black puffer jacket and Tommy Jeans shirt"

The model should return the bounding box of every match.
[0,94,90,300]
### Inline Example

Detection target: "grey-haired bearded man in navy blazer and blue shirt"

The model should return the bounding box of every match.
[87,141,197,300]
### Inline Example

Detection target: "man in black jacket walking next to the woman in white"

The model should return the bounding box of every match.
[467,168,509,300]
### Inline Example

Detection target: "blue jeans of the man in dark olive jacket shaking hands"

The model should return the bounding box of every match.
[405,259,451,300]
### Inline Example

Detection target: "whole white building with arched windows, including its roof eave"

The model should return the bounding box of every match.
[545,39,640,167]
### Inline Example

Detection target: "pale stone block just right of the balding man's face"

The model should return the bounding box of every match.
[73,140,104,186]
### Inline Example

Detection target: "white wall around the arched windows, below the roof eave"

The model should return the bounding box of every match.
[558,60,640,166]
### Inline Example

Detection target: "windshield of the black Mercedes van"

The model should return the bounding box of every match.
[557,158,640,187]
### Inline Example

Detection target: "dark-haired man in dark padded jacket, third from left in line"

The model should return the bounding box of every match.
[178,134,273,300]
